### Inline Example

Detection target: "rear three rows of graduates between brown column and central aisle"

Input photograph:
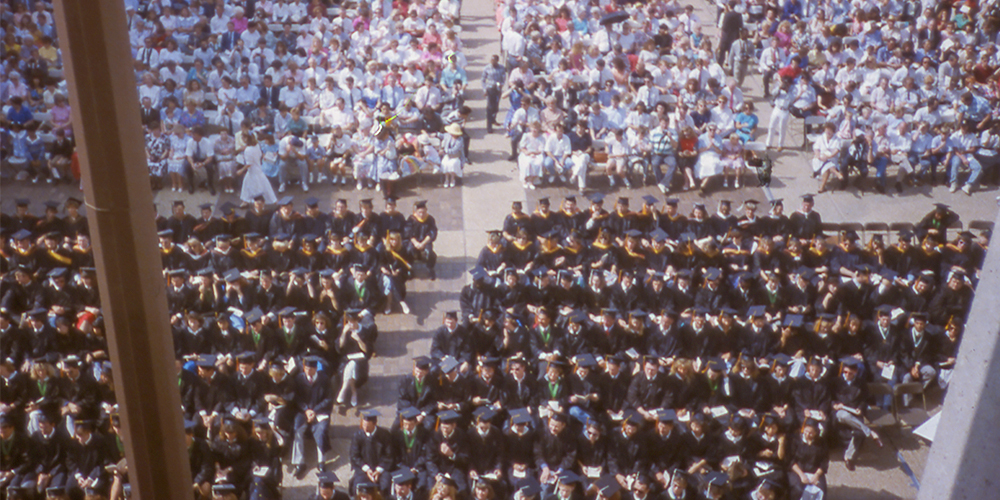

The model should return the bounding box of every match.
[151,192,437,315]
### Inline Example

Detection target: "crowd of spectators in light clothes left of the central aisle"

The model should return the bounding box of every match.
[0,0,471,198]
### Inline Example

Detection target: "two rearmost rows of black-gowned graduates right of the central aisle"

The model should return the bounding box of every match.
[477,193,989,292]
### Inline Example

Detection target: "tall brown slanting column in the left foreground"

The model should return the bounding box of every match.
[55,0,192,500]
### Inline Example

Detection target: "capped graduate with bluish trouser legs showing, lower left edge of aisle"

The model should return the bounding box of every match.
[291,356,333,480]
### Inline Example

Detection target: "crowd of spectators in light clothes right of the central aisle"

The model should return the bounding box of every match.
[496,0,1000,194]
